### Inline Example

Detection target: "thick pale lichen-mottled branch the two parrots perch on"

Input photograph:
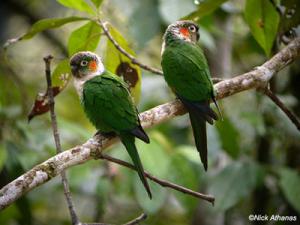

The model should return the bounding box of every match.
[0,38,300,209]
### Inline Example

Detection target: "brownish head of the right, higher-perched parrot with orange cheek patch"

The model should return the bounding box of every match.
[164,20,200,43]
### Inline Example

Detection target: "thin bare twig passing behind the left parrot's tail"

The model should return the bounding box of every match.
[98,153,215,204]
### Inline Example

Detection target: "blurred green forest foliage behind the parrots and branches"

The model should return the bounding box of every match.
[0,0,300,225]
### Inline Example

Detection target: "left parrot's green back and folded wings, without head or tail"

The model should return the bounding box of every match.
[82,71,139,133]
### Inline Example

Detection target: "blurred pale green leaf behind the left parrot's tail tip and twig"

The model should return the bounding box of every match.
[134,132,170,214]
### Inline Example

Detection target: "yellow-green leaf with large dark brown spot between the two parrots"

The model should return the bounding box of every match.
[104,25,142,104]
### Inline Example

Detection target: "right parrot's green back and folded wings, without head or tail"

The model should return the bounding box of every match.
[162,40,213,101]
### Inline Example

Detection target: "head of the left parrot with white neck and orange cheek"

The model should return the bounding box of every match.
[70,51,104,79]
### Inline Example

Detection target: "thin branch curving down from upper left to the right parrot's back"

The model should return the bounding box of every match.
[96,19,163,75]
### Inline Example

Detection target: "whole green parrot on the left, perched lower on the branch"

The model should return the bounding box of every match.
[70,52,152,199]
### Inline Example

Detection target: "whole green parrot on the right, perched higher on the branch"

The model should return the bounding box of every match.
[161,21,220,170]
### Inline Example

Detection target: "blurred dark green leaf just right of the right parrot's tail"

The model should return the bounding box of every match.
[216,117,240,159]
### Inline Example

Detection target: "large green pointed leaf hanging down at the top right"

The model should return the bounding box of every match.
[245,0,280,56]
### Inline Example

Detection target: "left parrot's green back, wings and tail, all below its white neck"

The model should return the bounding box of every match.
[82,71,152,198]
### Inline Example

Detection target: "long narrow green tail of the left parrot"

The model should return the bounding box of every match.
[120,133,152,199]
